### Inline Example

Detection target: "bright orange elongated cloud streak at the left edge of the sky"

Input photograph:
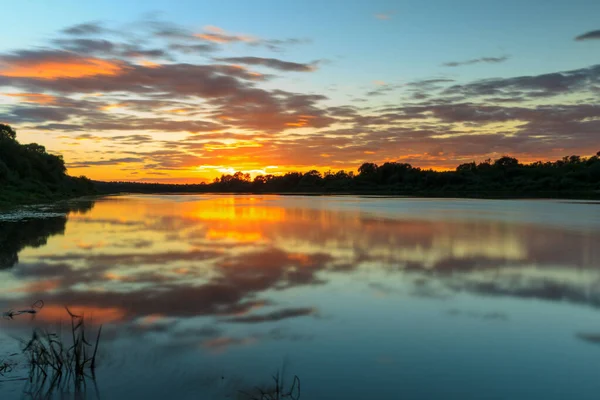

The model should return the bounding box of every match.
[0,58,123,79]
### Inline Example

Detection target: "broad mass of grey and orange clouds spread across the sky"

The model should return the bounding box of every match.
[0,20,600,174]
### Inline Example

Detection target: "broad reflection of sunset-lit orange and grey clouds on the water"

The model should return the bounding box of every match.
[0,197,600,349]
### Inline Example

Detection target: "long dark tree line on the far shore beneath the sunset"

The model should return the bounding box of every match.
[96,152,600,198]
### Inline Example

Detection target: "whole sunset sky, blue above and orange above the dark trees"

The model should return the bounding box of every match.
[0,0,600,183]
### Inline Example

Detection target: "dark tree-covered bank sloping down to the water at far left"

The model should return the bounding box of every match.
[0,124,95,207]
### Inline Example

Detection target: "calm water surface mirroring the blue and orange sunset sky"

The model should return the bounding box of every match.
[0,196,600,399]
